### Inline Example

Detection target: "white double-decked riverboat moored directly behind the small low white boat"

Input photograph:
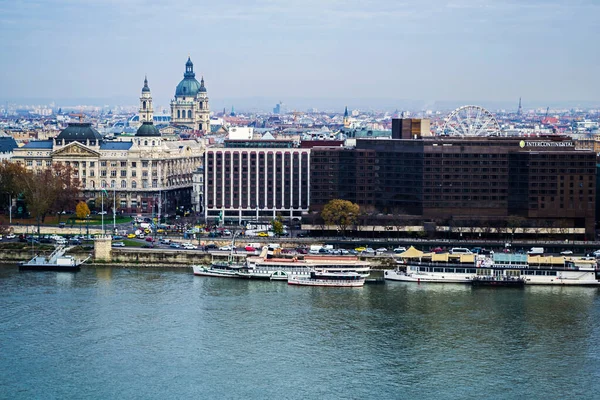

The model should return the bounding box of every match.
[240,250,371,281]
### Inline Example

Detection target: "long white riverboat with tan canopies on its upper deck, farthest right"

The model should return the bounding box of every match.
[384,253,600,286]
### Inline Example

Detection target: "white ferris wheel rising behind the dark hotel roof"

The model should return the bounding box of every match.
[442,106,501,136]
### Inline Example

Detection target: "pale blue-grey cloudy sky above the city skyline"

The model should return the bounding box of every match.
[0,0,600,109]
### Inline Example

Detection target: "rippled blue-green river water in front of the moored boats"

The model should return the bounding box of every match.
[0,267,600,400]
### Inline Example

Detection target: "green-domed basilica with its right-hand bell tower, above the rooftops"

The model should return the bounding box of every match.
[170,57,210,132]
